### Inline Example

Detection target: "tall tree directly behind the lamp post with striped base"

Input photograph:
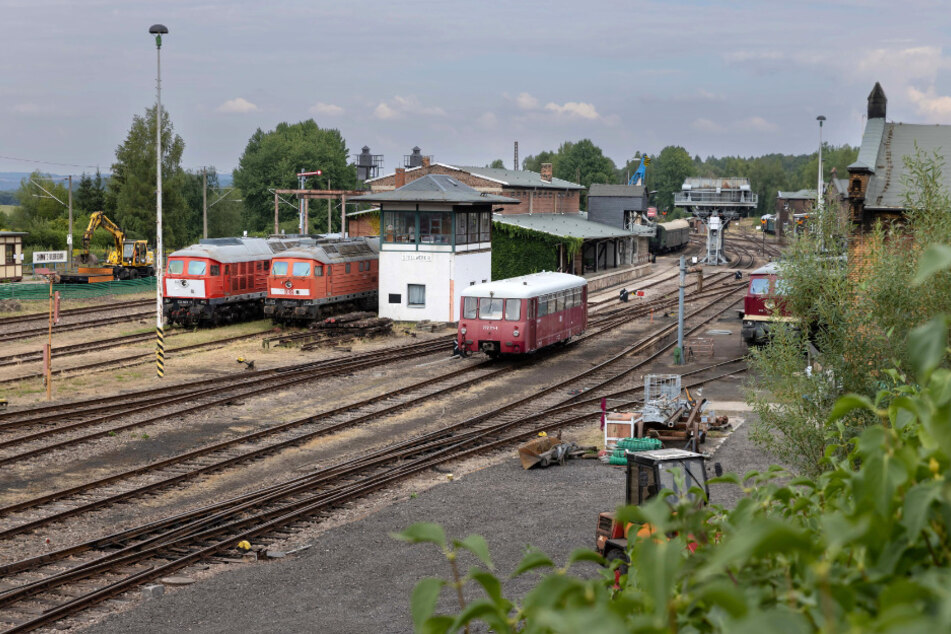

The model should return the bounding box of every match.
[109,107,192,247]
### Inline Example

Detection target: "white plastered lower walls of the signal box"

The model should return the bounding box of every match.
[379,251,492,321]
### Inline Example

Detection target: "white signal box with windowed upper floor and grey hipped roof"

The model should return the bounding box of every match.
[353,174,519,321]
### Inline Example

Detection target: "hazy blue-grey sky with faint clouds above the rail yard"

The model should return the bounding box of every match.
[0,0,951,174]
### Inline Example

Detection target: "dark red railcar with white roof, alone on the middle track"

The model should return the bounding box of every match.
[456,272,588,357]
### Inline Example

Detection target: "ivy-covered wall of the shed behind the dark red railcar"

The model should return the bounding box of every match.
[492,222,583,280]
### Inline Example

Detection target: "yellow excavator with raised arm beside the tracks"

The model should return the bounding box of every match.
[62,211,155,283]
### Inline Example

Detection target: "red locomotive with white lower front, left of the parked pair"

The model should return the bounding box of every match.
[163,238,273,326]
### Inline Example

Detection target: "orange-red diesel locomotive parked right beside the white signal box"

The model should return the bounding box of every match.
[264,237,380,323]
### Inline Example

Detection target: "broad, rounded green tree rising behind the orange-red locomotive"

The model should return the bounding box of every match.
[234,119,357,231]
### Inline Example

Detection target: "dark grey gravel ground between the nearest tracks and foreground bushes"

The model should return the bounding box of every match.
[85,414,788,634]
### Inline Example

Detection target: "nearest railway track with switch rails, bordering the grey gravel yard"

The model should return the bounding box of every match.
[0,284,752,632]
